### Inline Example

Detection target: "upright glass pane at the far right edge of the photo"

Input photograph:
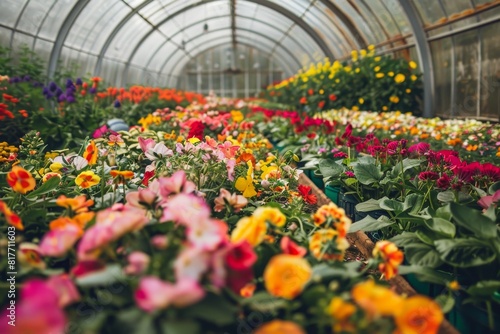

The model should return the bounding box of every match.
[480,22,500,121]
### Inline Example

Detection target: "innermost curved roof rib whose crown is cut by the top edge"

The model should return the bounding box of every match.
[123,0,335,83]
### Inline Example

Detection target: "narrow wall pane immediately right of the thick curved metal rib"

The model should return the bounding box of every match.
[430,38,453,117]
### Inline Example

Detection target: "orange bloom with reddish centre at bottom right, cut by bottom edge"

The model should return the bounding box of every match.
[395,295,443,334]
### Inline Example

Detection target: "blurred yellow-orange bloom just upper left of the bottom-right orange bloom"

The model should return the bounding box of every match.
[351,280,403,318]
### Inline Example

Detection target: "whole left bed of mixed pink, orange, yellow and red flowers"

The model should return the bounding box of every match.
[0,100,443,333]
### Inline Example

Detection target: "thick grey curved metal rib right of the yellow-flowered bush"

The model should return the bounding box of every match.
[399,0,435,117]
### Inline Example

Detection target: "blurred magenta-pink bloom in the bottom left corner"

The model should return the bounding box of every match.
[0,279,66,334]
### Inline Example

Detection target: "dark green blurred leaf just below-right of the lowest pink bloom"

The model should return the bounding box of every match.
[185,293,238,326]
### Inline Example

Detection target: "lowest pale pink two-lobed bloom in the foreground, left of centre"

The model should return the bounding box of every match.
[135,276,205,312]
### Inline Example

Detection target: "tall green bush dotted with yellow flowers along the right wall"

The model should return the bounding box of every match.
[265,46,422,113]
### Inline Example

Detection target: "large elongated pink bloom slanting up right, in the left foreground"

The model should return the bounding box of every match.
[78,204,149,260]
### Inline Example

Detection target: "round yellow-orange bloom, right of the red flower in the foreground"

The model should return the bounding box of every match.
[264,254,312,299]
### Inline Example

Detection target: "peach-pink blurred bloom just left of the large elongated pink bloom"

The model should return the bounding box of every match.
[38,224,82,257]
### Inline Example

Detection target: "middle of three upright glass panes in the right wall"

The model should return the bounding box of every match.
[453,31,479,117]
